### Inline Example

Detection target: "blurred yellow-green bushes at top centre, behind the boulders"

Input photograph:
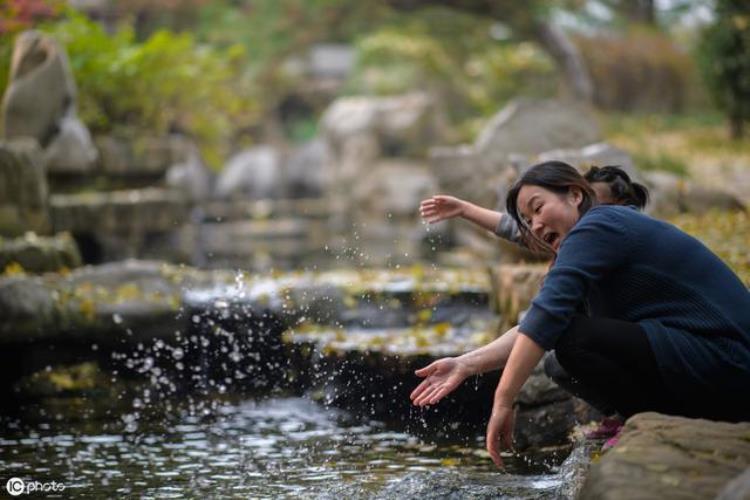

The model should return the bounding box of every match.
[347,8,557,140]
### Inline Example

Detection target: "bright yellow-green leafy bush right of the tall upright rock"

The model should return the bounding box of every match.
[29,11,254,165]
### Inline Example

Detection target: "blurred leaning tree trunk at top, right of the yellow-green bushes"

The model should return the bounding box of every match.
[533,22,594,103]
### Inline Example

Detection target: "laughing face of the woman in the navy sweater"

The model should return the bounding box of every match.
[518,185,583,252]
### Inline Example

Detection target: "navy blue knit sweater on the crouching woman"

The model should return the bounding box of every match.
[519,205,750,397]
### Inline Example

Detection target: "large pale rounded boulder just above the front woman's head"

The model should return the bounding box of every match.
[475,99,601,168]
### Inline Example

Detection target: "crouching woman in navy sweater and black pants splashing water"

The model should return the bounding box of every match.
[411,162,750,466]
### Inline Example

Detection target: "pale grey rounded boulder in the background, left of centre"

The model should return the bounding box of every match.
[214,146,282,199]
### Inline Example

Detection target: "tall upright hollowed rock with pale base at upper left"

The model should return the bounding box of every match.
[3,31,97,173]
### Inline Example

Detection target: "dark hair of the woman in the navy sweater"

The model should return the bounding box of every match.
[505,161,597,252]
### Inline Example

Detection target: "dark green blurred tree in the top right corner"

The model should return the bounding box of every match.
[698,0,750,139]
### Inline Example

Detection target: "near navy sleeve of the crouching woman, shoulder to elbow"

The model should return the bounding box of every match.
[519,207,634,350]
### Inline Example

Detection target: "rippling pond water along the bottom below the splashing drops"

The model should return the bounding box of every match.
[0,394,561,498]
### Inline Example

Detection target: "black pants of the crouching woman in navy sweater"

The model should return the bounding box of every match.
[545,315,748,420]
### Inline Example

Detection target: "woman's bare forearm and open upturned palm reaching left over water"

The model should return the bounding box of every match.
[409,327,518,406]
